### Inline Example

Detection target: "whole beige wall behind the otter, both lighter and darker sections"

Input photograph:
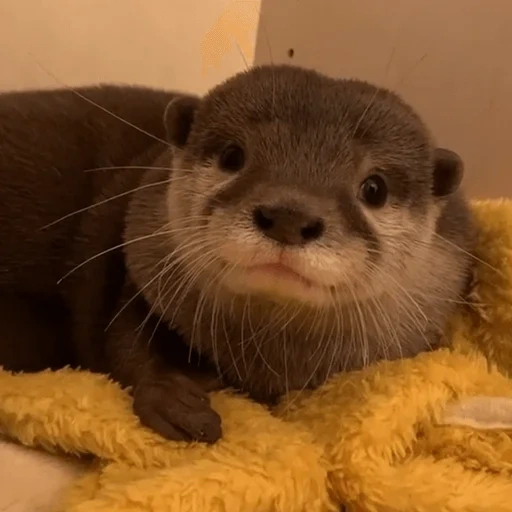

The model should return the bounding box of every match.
[0,0,512,196]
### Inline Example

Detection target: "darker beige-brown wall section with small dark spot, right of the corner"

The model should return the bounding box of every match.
[256,0,512,196]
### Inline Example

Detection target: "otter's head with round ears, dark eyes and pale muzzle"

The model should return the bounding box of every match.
[166,66,462,307]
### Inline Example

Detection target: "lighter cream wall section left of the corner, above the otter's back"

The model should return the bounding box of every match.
[0,0,259,93]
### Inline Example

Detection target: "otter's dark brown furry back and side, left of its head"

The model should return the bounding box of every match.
[0,86,173,370]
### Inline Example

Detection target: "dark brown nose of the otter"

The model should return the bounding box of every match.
[253,206,325,245]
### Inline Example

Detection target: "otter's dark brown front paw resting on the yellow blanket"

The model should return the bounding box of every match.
[133,373,222,443]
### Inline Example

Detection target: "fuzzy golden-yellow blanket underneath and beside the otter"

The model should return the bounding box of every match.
[0,201,512,512]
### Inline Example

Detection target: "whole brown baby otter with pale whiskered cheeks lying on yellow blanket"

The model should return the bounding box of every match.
[0,66,473,442]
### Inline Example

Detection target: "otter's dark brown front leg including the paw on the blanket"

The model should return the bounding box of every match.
[107,287,222,443]
